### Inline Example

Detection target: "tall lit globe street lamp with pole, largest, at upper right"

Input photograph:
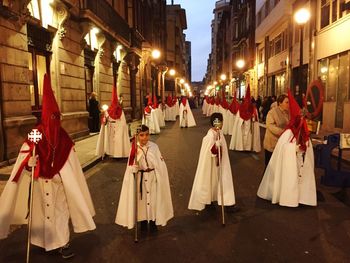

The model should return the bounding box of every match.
[294,8,310,105]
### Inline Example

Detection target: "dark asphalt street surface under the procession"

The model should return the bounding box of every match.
[0,109,350,263]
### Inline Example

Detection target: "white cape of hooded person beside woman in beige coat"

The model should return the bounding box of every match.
[257,129,317,207]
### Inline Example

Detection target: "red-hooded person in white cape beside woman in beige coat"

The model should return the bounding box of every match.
[257,91,317,207]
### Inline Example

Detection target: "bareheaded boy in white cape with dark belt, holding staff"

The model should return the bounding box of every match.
[115,125,174,232]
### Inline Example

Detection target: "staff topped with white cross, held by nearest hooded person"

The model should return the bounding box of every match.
[26,129,42,263]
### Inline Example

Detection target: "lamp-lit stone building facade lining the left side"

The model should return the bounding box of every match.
[0,0,170,163]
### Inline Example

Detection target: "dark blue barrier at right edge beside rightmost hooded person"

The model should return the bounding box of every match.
[315,133,350,187]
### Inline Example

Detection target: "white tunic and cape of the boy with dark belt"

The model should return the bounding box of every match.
[115,142,174,229]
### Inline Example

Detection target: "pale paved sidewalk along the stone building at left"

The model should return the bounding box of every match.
[0,121,141,194]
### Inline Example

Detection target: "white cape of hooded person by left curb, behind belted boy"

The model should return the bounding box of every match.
[96,112,130,158]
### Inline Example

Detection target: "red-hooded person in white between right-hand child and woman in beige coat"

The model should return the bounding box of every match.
[230,85,261,152]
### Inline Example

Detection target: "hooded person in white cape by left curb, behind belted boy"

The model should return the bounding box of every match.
[96,86,130,158]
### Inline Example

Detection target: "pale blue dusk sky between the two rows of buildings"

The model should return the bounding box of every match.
[167,0,216,81]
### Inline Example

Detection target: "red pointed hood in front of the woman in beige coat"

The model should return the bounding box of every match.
[287,90,310,151]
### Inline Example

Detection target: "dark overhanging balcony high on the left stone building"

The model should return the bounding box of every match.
[80,0,130,43]
